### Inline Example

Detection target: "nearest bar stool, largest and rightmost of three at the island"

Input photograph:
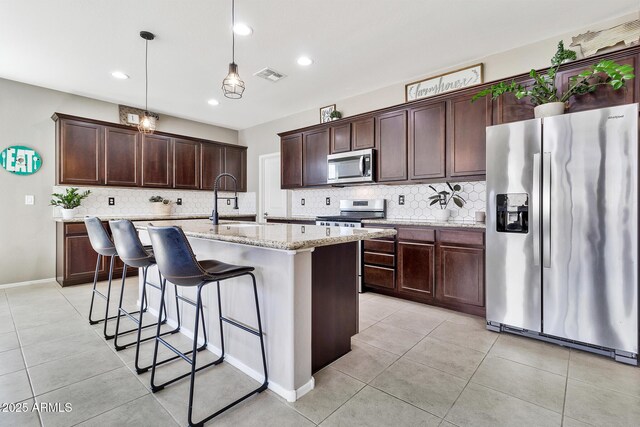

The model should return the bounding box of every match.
[147,226,269,426]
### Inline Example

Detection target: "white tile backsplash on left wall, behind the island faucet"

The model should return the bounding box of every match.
[52,186,256,217]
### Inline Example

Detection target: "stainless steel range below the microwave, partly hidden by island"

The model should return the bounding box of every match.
[316,199,387,292]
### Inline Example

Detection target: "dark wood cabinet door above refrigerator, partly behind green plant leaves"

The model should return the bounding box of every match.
[557,54,638,113]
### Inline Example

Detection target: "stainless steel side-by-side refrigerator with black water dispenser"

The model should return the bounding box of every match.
[486,104,639,365]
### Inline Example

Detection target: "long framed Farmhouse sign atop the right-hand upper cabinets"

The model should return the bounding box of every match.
[404,64,483,102]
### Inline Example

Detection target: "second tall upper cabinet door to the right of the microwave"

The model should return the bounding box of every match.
[409,102,446,180]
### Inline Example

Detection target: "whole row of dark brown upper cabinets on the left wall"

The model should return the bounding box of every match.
[51,113,247,191]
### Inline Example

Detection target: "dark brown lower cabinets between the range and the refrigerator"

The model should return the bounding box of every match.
[362,227,485,316]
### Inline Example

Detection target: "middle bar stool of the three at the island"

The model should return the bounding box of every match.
[109,220,180,374]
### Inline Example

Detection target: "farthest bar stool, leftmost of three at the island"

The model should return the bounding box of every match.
[84,216,137,340]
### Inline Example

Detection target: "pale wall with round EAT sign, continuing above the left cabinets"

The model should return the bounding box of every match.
[0,79,238,284]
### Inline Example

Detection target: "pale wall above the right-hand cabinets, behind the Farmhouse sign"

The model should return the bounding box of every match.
[239,9,640,197]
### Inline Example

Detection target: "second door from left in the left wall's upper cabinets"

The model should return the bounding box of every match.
[104,127,141,187]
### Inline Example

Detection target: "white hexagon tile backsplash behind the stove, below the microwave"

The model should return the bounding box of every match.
[291,181,486,222]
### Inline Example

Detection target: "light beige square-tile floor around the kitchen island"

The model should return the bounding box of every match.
[0,279,640,427]
